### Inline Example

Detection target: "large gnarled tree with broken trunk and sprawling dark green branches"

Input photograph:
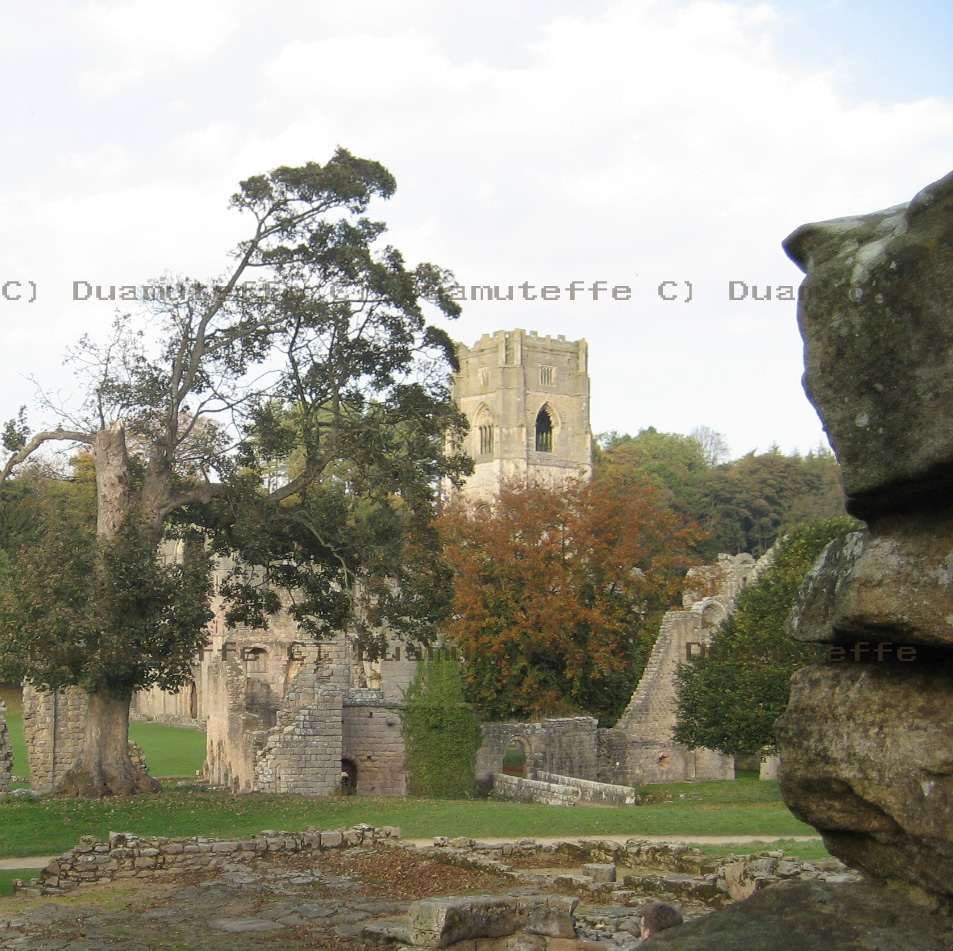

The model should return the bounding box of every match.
[0,150,465,795]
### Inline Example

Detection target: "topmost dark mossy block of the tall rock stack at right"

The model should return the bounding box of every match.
[785,174,953,519]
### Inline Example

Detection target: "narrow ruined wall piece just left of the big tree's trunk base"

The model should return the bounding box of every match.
[23,684,86,794]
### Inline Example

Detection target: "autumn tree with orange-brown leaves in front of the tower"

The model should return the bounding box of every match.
[441,480,702,723]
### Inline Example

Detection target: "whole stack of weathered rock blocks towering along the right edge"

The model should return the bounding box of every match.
[777,175,953,908]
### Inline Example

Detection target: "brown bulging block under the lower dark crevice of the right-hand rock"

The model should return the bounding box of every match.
[778,664,953,892]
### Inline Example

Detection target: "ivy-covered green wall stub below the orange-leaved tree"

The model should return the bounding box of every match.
[402,658,482,799]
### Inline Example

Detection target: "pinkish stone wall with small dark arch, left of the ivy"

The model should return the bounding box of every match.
[341,689,407,796]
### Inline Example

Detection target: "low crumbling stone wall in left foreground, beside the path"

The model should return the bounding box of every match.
[15,825,400,895]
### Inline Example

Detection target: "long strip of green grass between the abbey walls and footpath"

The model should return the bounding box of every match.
[0,781,814,856]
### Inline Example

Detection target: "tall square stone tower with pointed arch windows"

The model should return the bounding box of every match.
[453,330,592,499]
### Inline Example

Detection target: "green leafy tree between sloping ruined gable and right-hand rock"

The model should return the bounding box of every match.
[675,518,857,756]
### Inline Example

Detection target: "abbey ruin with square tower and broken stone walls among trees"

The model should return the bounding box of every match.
[14,330,760,796]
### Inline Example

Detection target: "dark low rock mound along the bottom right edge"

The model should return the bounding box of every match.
[649,882,953,951]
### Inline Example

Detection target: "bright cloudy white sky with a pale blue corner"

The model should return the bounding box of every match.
[0,0,953,456]
